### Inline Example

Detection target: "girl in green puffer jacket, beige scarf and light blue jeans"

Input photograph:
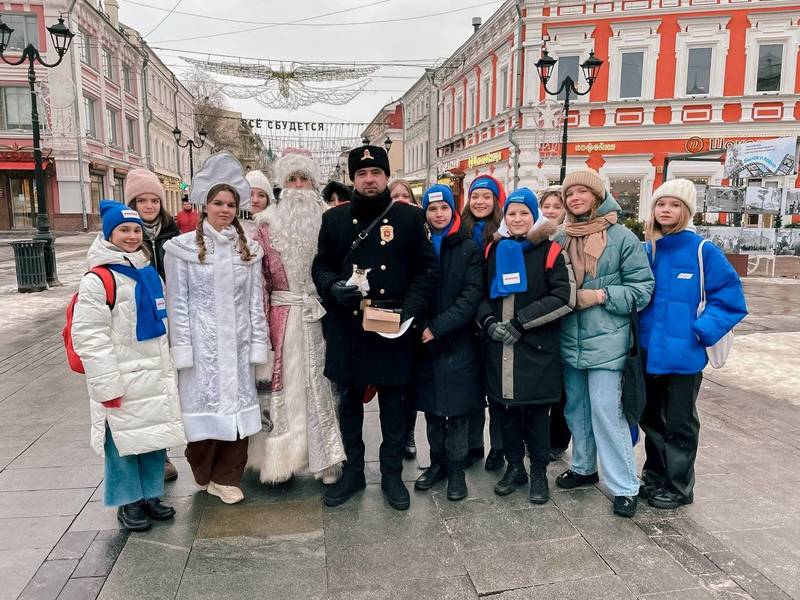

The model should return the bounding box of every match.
[556,169,654,517]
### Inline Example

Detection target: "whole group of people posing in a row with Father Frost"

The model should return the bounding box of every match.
[71,145,747,530]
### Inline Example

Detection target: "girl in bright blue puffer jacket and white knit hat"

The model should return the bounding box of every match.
[639,179,747,508]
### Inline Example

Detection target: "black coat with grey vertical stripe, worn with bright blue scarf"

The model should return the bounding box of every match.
[478,241,576,405]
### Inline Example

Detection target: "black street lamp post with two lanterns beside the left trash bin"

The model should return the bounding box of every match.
[0,17,75,286]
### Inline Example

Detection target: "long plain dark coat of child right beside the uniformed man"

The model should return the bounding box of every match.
[414,229,483,417]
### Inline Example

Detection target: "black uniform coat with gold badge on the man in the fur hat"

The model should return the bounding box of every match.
[311,190,437,386]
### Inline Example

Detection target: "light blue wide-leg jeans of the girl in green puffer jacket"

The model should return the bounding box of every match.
[564,364,639,496]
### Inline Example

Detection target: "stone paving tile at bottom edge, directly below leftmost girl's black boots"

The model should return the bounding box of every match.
[98,537,189,600]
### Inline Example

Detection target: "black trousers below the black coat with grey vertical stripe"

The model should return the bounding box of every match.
[498,404,550,470]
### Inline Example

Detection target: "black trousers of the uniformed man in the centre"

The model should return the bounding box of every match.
[340,386,407,475]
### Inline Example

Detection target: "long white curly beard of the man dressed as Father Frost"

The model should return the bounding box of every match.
[263,189,325,288]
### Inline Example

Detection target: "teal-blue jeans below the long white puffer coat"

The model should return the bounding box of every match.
[103,426,167,506]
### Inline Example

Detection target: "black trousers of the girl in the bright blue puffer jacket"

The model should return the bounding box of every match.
[640,372,703,499]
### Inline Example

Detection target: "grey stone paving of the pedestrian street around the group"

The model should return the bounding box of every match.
[0,238,800,600]
